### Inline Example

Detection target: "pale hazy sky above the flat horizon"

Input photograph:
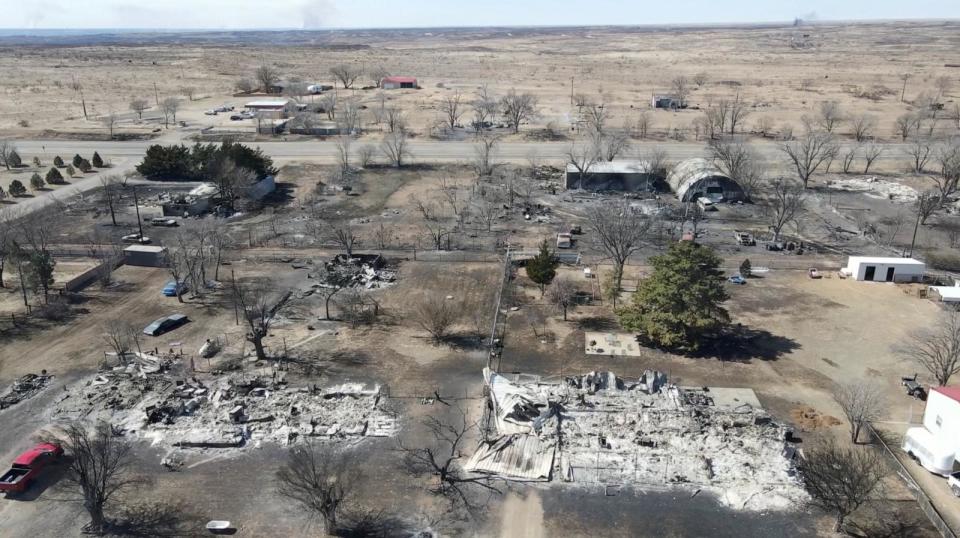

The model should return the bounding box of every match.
[0,0,960,28]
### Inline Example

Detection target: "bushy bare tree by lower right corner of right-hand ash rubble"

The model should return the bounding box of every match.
[798,439,888,532]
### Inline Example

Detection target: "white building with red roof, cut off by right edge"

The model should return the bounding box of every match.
[903,386,960,476]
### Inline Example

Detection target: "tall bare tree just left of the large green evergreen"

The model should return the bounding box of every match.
[587,201,653,289]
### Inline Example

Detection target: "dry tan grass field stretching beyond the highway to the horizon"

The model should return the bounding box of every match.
[0,22,960,138]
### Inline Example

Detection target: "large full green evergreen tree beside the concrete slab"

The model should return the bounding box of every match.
[617,241,730,351]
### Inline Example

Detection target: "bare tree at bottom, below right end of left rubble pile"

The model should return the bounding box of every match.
[277,441,361,536]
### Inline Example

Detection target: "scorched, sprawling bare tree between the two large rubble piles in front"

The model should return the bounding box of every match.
[397,406,500,507]
